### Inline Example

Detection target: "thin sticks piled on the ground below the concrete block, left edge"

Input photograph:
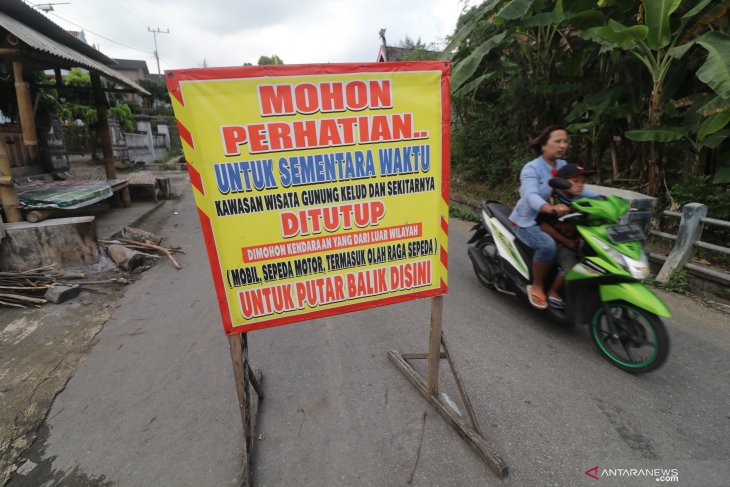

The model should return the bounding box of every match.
[0,264,131,308]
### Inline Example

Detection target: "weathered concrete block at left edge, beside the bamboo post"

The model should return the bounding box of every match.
[0,216,100,271]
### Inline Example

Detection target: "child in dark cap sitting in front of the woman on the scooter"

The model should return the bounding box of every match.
[537,164,595,309]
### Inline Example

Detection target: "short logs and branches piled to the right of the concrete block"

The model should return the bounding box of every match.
[99,227,184,272]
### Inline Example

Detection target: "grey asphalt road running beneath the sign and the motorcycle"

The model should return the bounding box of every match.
[9,186,730,487]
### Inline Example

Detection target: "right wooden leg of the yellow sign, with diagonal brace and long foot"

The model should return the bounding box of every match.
[388,296,508,478]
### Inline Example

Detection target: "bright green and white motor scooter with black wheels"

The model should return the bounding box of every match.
[469,178,671,374]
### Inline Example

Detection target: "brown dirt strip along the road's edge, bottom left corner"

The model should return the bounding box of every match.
[0,286,122,485]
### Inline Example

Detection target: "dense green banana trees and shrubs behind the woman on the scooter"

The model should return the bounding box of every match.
[442,0,730,202]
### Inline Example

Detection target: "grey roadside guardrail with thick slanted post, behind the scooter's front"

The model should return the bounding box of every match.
[649,203,730,284]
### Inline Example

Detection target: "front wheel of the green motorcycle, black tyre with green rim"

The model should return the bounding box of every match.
[591,302,669,374]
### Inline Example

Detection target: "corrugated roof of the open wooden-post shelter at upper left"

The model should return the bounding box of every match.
[0,0,149,94]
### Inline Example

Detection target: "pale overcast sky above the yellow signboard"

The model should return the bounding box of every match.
[34,0,478,73]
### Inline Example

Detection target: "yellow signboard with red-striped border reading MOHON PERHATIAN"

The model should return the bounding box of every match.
[166,61,450,334]
